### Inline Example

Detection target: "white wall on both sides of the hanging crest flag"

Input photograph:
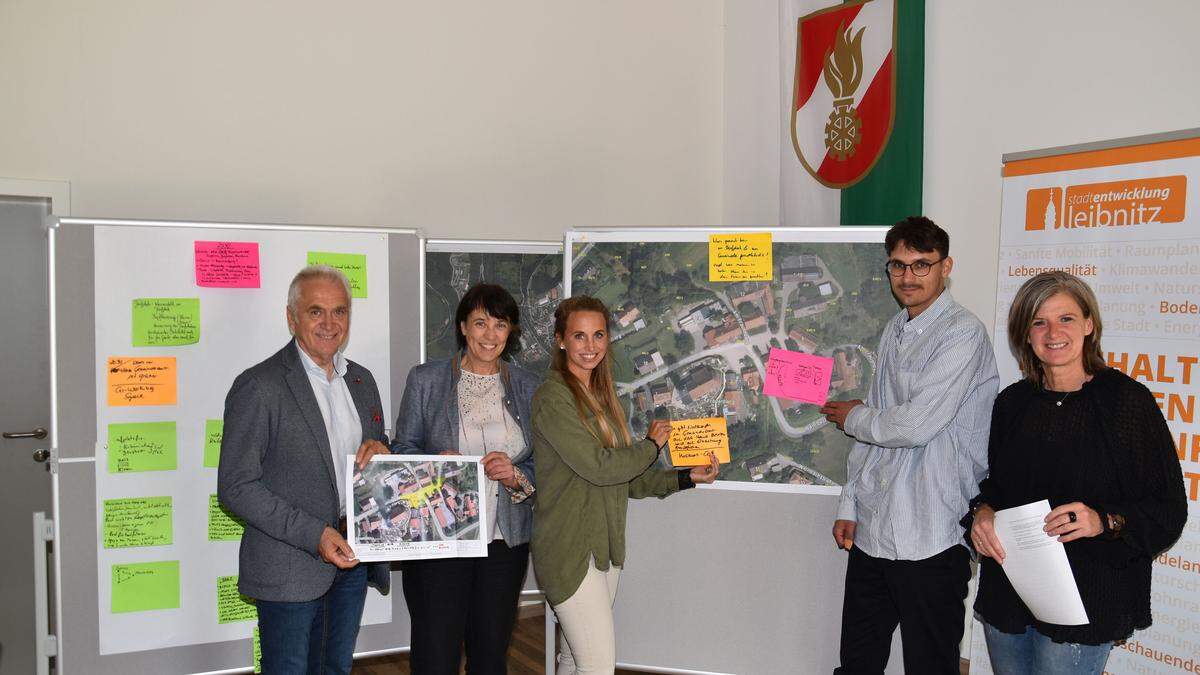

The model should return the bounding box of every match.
[722,0,1200,327]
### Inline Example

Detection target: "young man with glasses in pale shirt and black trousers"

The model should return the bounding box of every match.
[821,216,998,675]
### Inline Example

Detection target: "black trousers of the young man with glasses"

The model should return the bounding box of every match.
[834,545,971,675]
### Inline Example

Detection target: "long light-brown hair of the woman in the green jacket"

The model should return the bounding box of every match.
[550,295,634,448]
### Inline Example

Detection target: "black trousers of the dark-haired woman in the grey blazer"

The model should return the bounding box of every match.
[401,539,529,675]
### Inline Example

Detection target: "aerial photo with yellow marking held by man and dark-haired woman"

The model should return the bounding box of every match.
[354,461,480,544]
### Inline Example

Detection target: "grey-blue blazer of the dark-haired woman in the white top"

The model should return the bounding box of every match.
[391,356,541,546]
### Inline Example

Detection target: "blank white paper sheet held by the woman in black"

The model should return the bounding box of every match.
[995,500,1087,626]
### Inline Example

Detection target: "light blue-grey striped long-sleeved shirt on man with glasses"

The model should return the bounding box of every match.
[838,291,1000,560]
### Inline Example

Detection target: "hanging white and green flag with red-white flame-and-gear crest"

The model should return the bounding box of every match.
[780,0,925,227]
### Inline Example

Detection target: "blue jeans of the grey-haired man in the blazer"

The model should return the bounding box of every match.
[256,565,367,675]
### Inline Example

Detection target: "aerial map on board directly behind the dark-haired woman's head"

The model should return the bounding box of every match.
[425,251,563,376]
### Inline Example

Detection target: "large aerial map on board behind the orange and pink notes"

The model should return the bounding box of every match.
[569,233,898,491]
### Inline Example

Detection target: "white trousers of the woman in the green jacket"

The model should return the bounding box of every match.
[554,560,620,675]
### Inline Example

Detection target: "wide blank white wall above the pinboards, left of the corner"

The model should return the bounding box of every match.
[0,0,722,239]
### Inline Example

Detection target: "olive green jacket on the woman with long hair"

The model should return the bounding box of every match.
[532,370,679,605]
